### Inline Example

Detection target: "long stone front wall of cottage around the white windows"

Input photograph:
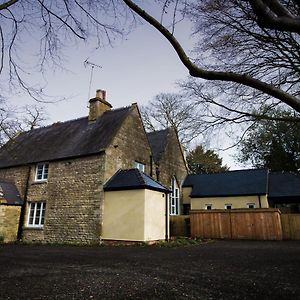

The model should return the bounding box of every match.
[23,155,104,243]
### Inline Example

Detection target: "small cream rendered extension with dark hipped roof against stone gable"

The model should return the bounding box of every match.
[102,169,170,242]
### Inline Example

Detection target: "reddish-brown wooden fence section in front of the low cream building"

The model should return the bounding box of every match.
[190,209,283,240]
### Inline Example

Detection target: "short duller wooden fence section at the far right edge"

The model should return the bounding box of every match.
[281,214,300,240]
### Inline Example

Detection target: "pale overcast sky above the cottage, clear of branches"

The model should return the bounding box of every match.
[11,7,237,169]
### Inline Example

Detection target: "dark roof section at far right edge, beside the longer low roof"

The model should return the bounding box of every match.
[269,172,300,202]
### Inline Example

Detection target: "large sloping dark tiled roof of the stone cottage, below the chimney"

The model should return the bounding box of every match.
[0,107,130,168]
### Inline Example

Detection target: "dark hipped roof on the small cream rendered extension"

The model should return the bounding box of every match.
[104,169,169,193]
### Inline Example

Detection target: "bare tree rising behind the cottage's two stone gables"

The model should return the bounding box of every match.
[141,93,202,147]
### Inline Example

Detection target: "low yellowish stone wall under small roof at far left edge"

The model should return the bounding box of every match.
[0,204,21,243]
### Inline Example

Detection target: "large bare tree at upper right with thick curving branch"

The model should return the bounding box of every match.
[124,0,300,112]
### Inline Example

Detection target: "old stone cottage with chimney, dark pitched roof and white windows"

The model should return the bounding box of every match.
[0,90,187,243]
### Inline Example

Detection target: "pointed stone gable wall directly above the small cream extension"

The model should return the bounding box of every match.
[105,105,151,180]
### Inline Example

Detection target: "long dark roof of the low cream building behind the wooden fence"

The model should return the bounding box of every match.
[183,169,268,198]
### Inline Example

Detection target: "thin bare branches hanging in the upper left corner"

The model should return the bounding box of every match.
[0,0,135,101]
